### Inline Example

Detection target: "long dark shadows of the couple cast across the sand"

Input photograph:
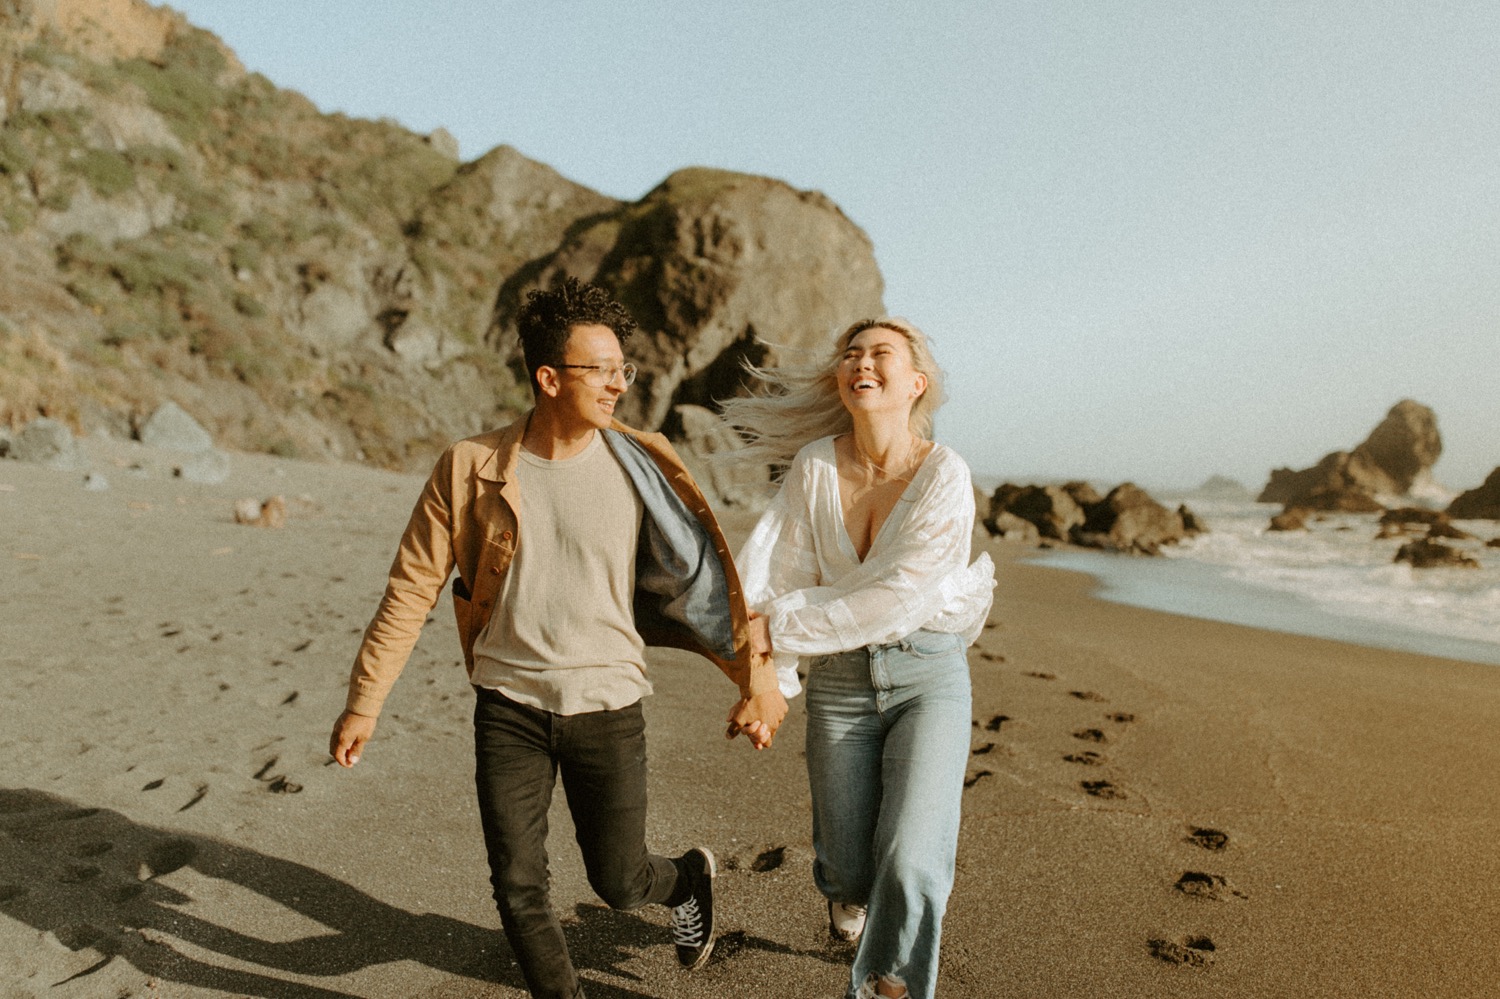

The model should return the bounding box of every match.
[0,788,825,999]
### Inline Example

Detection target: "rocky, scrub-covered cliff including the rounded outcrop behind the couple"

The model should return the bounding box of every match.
[0,0,882,470]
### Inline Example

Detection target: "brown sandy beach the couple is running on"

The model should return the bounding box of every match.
[0,440,1500,999]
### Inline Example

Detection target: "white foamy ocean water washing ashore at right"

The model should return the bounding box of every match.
[1037,498,1500,666]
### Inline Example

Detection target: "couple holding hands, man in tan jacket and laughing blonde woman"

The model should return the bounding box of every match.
[330,279,995,999]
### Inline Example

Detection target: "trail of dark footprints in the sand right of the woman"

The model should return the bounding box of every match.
[963,651,1250,969]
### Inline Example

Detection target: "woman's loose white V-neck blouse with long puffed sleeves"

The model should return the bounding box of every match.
[737,437,995,698]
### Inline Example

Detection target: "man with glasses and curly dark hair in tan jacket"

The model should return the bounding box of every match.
[330,278,786,999]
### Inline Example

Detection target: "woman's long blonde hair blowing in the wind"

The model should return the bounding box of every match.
[714,317,944,474]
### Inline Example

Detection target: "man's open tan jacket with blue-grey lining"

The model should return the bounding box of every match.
[347,414,776,717]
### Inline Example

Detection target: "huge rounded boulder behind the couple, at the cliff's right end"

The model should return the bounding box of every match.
[485,167,885,429]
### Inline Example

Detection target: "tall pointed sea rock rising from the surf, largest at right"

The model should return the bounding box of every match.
[1257,399,1443,513]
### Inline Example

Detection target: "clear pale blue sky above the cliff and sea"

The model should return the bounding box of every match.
[171,0,1500,489]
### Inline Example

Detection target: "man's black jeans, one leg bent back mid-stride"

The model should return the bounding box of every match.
[474,687,686,999]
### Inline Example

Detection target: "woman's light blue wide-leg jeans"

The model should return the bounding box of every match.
[807,630,971,999]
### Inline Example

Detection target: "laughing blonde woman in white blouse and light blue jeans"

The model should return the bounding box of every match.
[725,318,995,999]
